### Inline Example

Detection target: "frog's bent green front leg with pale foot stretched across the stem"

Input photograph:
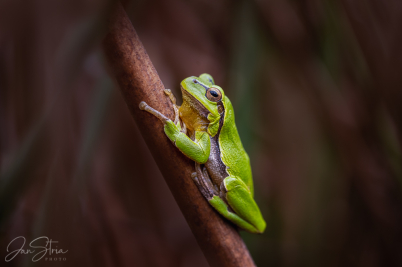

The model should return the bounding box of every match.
[139,101,211,164]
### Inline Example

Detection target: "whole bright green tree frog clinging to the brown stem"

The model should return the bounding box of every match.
[140,73,266,233]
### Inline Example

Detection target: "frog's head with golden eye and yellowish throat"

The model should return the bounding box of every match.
[180,73,225,136]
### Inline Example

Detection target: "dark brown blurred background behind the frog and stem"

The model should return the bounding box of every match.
[0,0,402,267]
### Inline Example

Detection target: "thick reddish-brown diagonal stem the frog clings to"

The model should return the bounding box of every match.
[103,2,254,266]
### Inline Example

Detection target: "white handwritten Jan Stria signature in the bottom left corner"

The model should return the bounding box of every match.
[5,236,68,262]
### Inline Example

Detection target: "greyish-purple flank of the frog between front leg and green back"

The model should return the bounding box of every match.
[205,135,229,188]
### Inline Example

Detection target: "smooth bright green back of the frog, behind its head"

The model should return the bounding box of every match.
[219,97,254,195]
